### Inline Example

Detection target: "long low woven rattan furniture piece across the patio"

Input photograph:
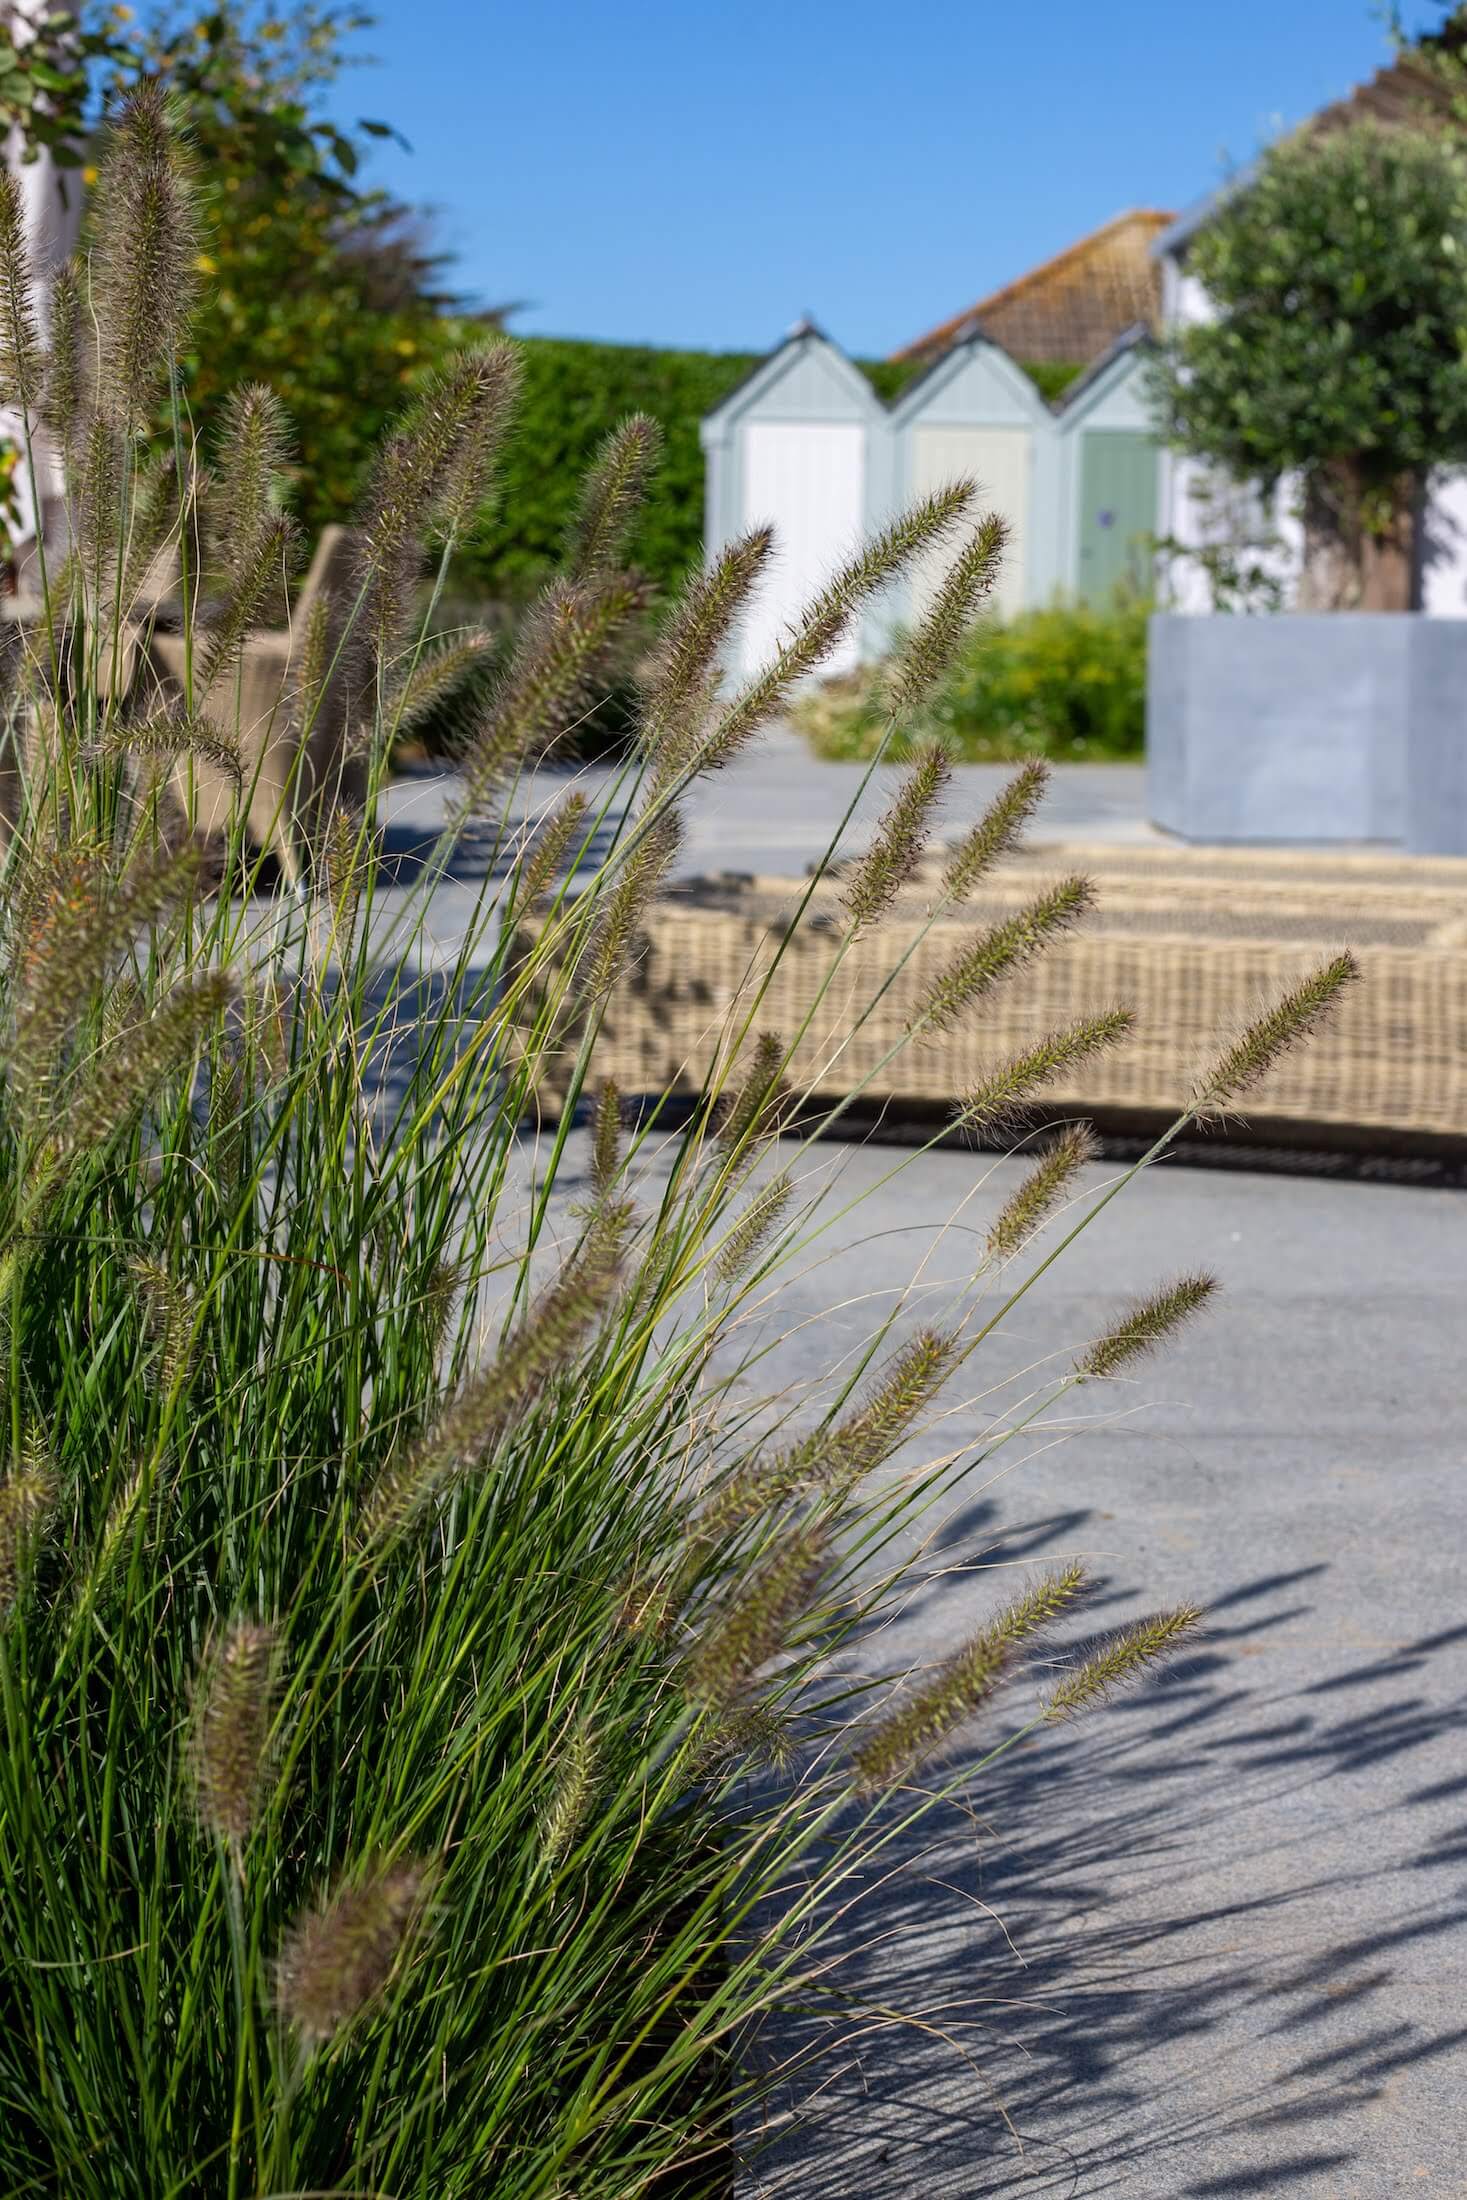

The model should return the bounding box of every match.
[521,845,1467,1144]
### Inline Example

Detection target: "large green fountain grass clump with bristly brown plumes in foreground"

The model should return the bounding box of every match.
[0,85,1342,2200]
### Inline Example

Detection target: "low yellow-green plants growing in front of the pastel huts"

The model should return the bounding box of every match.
[792,594,1148,763]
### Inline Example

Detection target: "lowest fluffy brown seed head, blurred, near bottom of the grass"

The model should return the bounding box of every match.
[275,1859,435,2053]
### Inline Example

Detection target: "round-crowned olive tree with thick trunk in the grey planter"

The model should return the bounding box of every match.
[1157,121,1467,612]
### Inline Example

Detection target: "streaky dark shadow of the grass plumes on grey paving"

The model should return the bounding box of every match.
[741,1548,1467,2200]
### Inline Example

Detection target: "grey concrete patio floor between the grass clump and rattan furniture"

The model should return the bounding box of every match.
[743,1151,1467,2200]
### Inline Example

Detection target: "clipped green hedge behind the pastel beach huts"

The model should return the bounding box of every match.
[457,337,915,603]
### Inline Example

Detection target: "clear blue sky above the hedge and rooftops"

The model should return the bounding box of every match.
[334,0,1438,354]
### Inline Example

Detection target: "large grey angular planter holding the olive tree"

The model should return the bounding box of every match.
[1146,612,1467,854]
